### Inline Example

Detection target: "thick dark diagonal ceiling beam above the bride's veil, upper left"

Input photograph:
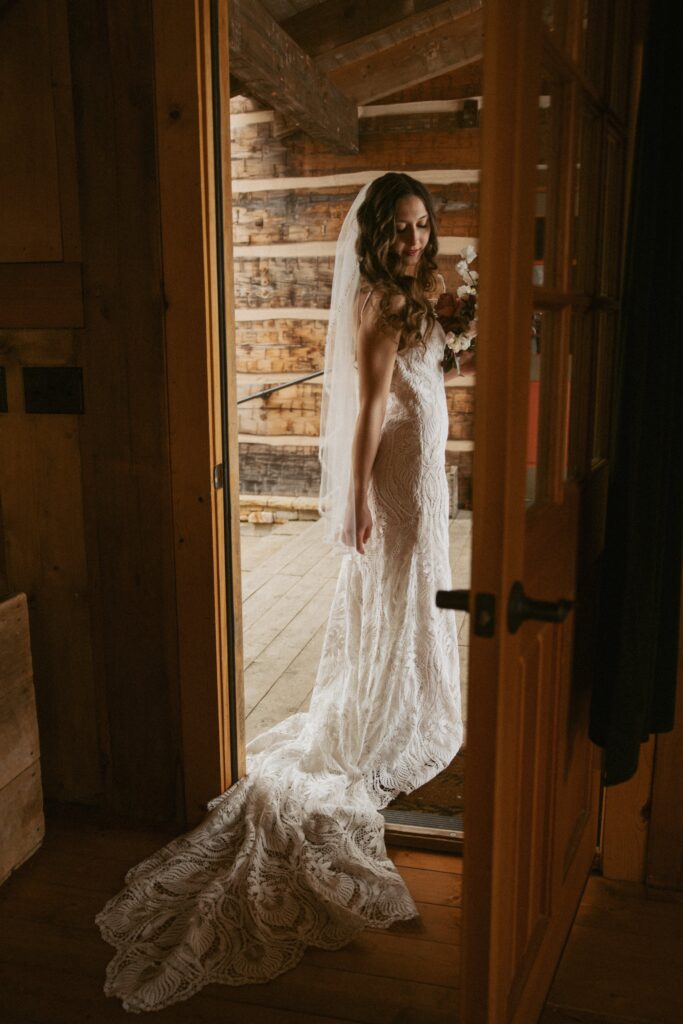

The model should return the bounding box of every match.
[229,0,358,153]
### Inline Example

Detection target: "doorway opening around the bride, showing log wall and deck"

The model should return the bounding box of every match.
[230,60,481,849]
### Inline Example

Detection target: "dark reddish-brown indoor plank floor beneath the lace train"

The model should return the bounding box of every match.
[0,818,683,1024]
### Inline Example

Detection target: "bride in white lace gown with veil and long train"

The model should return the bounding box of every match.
[95,173,463,1012]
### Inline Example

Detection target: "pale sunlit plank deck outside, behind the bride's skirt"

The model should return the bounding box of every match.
[240,511,472,740]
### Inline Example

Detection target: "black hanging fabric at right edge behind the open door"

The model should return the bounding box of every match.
[589,0,683,785]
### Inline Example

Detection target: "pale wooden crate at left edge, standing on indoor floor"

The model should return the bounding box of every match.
[0,594,45,885]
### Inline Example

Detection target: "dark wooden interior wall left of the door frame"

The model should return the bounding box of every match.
[0,0,179,820]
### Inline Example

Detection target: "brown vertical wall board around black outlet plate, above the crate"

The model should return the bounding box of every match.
[0,348,103,802]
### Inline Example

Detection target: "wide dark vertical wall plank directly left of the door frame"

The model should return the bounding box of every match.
[66,0,179,820]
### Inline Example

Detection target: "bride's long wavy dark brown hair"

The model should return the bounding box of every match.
[355,171,438,348]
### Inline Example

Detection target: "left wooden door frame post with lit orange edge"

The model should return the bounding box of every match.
[153,0,245,826]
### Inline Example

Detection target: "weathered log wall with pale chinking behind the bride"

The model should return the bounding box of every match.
[230,66,480,508]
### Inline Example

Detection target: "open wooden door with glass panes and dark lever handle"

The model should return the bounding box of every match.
[462,0,643,1024]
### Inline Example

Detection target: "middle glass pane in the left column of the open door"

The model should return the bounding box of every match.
[531,75,566,288]
